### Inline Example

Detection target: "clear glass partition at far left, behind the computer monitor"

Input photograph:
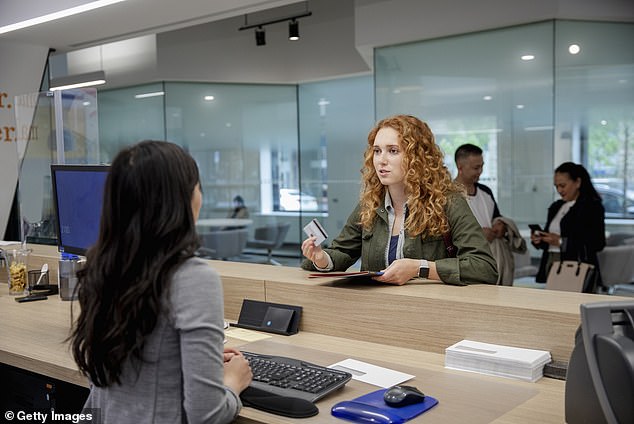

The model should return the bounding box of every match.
[15,88,99,244]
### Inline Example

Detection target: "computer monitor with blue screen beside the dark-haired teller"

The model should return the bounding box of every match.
[51,164,110,255]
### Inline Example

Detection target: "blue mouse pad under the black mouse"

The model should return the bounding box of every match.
[331,389,438,424]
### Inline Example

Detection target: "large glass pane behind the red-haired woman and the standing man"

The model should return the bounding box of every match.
[375,22,553,222]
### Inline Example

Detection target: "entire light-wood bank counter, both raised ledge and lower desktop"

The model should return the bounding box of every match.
[0,245,625,423]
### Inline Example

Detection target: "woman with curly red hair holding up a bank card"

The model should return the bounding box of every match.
[302,115,497,285]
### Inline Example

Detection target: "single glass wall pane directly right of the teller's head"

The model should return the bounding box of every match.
[165,83,299,225]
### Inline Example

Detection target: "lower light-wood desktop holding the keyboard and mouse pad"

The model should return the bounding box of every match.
[0,290,564,424]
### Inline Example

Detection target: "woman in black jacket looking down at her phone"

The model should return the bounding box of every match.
[531,162,605,293]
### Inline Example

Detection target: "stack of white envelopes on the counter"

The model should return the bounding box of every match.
[445,340,551,382]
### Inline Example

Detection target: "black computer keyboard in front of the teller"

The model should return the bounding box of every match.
[242,352,352,402]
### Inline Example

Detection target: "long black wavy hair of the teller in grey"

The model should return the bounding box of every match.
[70,140,199,387]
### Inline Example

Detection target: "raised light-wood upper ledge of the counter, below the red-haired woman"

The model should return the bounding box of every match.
[8,245,629,361]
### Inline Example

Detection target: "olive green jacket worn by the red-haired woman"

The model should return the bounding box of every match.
[302,196,498,285]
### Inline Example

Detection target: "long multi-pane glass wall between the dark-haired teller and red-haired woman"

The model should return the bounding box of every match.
[93,75,374,250]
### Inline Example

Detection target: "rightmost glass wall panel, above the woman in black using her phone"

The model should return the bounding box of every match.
[555,21,634,222]
